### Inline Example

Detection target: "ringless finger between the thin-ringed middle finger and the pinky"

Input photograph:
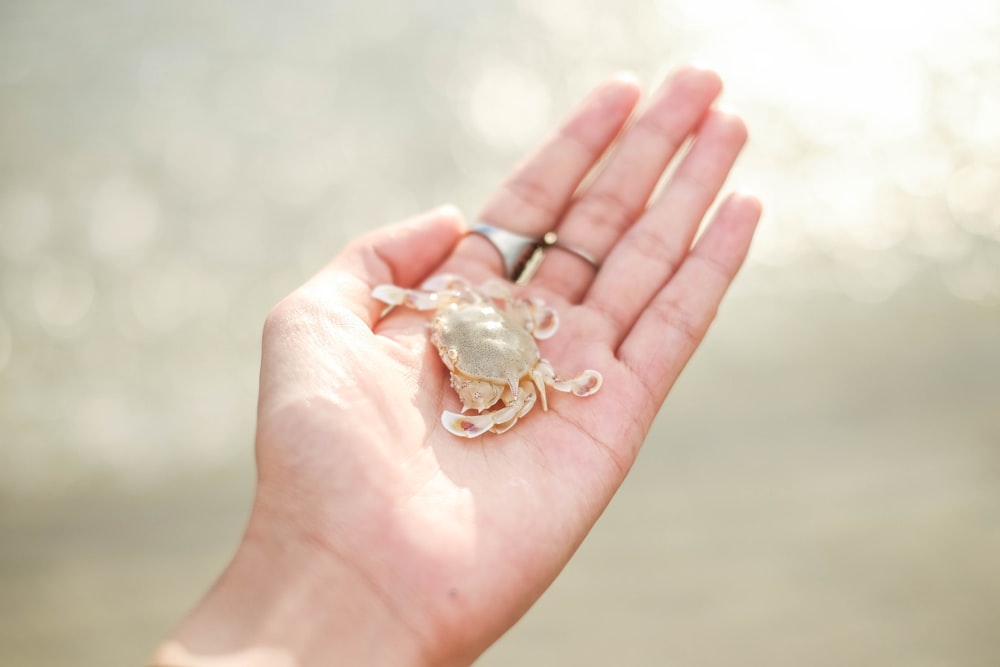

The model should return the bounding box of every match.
[584,110,747,349]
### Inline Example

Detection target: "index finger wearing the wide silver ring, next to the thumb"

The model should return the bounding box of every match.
[445,75,641,279]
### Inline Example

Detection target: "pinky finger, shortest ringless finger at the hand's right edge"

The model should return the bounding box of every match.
[618,194,761,406]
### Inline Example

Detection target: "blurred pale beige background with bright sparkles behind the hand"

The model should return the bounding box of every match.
[0,0,1000,667]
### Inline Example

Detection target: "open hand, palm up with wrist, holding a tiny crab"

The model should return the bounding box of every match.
[158,69,760,665]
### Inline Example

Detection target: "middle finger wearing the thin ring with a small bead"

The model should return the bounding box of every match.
[532,67,722,301]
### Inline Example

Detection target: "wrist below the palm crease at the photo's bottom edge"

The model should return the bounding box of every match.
[152,522,424,667]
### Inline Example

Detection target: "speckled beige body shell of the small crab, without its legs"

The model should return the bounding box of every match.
[431,302,540,411]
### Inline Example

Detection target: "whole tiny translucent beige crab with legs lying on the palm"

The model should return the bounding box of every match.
[372,275,602,438]
